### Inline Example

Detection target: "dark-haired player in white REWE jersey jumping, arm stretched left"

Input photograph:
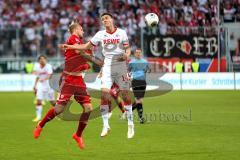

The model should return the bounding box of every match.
[60,13,134,138]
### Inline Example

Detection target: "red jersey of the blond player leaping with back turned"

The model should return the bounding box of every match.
[64,35,90,72]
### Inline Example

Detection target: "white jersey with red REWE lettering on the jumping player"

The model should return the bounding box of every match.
[90,28,129,65]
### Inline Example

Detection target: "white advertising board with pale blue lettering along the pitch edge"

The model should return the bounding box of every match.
[0,72,240,92]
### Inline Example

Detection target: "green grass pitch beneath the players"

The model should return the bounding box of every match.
[0,91,240,160]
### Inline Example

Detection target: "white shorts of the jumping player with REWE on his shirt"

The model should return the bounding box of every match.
[101,63,131,90]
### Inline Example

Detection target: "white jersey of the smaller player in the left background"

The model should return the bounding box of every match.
[33,63,53,89]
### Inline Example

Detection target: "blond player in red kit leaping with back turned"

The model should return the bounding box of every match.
[33,22,92,149]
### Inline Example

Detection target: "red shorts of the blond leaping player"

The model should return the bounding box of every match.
[57,73,91,105]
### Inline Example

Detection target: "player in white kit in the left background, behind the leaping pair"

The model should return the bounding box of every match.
[33,55,55,122]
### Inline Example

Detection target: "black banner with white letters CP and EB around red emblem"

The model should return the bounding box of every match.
[144,35,218,58]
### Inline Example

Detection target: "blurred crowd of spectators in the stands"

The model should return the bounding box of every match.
[0,0,240,57]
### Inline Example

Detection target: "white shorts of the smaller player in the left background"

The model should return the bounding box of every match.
[36,89,55,101]
